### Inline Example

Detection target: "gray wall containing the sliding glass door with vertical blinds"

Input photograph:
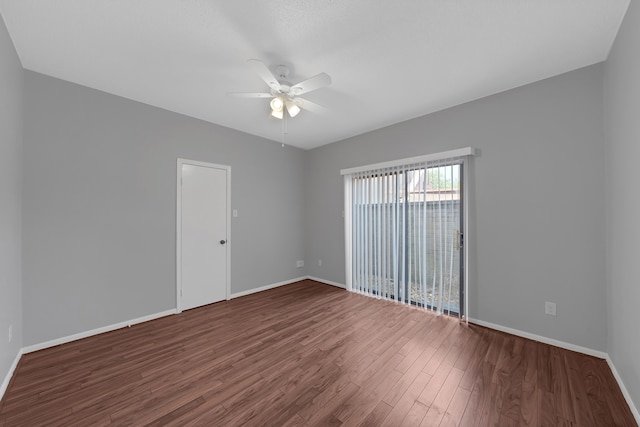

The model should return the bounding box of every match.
[305,64,606,351]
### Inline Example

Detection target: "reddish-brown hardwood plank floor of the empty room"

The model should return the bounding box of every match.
[0,281,637,426]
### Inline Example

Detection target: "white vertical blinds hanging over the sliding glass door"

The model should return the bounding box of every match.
[343,151,466,316]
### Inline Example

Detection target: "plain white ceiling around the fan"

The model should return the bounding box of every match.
[0,0,629,149]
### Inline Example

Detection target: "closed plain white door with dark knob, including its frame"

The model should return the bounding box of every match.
[176,159,230,311]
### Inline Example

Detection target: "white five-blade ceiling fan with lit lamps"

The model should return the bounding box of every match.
[228,59,331,119]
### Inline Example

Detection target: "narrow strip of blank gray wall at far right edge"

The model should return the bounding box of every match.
[605,1,640,408]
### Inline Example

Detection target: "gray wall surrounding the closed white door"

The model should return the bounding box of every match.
[23,71,305,345]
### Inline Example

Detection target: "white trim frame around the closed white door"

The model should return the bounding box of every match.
[176,157,231,313]
